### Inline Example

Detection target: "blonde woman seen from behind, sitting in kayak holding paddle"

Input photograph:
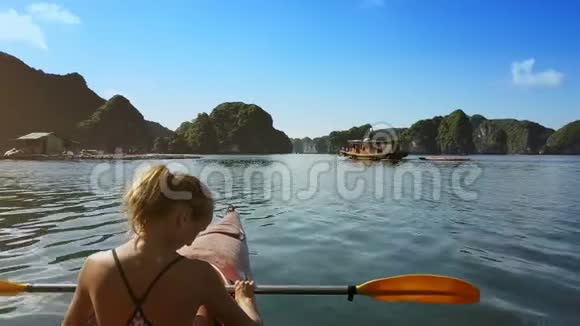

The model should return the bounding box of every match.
[63,166,261,326]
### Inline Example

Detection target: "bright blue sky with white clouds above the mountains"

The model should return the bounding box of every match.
[0,0,580,137]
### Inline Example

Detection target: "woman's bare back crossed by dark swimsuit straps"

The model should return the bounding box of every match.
[89,245,207,325]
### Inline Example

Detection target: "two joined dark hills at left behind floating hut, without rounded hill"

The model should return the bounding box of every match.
[0,52,174,152]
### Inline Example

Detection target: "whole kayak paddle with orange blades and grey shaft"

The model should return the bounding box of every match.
[0,274,479,304]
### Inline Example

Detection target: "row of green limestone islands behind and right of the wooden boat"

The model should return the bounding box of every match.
[302,110,580,154]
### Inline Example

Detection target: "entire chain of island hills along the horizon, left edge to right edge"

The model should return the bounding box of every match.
[0,52,580,154]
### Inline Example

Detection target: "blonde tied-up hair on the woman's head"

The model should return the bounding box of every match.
[123,165,213,236]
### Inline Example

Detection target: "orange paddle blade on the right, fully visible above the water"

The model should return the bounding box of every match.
[356,274,479,304]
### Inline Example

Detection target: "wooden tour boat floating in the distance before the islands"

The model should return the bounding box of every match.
[340,138,407,161]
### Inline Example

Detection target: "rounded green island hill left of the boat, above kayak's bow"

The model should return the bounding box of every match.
[176,102,292,154]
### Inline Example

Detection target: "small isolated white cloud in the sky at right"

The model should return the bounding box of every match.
[512,58,564,87]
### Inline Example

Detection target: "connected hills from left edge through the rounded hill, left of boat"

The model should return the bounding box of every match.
[0,52,292,154]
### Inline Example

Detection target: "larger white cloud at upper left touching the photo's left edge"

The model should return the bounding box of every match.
[0,9,48,50]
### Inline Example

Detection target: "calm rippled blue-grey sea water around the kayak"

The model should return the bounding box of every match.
[0,155,580,325]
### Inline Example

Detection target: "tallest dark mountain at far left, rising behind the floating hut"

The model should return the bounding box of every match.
[0,52,104,149]
